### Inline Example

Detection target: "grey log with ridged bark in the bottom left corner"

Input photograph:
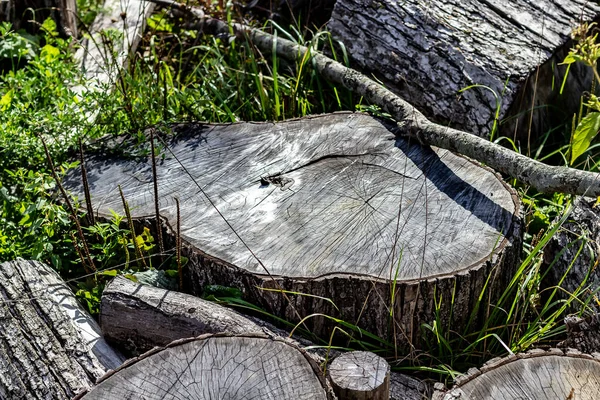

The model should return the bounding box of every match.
[0,259,124,399]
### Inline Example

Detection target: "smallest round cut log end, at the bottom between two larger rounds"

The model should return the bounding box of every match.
[329,351,390,400]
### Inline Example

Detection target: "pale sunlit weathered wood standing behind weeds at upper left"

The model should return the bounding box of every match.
[75,0,154,90]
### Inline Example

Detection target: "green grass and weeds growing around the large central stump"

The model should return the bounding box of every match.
[0,0,600,379]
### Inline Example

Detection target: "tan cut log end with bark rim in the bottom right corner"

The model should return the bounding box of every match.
[433,349,600,400]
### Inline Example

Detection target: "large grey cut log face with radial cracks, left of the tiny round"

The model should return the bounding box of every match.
[76,335,335,400]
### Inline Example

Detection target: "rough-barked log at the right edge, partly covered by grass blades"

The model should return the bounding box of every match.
[542,197,600,313]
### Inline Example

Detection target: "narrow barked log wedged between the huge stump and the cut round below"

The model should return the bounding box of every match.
[100,277,428,400]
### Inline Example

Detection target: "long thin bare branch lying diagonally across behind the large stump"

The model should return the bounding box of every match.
[148,0,600,196]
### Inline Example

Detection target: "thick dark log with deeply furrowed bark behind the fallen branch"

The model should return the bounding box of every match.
[328,0,600,144]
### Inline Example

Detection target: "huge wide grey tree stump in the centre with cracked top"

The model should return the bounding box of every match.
[65,113,521,343]
